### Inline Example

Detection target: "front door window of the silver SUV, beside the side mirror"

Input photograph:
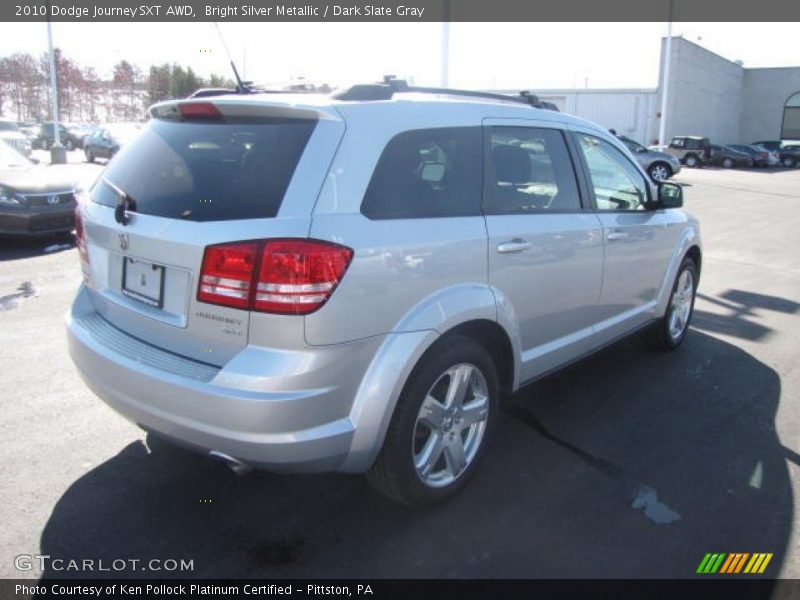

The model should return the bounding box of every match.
[577,134,647,210]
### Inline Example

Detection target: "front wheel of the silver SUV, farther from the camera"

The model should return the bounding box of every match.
[644,257,698,350]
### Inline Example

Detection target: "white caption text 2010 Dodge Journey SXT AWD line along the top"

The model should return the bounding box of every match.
[14,3,425,20]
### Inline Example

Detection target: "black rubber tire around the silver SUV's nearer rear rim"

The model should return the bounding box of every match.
[366,335,500,506]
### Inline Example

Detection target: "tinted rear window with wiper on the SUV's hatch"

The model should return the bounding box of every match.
[93,118,316,221]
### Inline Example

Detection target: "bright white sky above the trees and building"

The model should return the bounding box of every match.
[0,22,800,89]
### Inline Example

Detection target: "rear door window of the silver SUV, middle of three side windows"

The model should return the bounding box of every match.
[483,127,581,214]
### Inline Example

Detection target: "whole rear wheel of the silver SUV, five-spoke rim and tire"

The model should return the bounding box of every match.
[367,336,499,506]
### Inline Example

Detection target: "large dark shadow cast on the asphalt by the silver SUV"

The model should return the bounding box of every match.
[41,330,797,579]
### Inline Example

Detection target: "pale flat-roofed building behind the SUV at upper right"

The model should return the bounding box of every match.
[500,37,800,144]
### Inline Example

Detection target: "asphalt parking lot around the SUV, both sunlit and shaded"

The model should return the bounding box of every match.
[0,158,800,578]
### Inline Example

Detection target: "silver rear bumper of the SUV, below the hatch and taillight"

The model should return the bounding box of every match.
[67,288,383,472]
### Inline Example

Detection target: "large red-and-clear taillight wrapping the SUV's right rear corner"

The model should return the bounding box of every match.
[197,240,353,315]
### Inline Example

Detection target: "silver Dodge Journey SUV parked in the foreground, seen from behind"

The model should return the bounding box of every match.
[72,84,701,505]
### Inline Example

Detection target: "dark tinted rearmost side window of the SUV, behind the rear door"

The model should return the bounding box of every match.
[361,127,483,219]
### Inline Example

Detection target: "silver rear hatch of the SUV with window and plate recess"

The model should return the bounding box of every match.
[79,95,344,365]
